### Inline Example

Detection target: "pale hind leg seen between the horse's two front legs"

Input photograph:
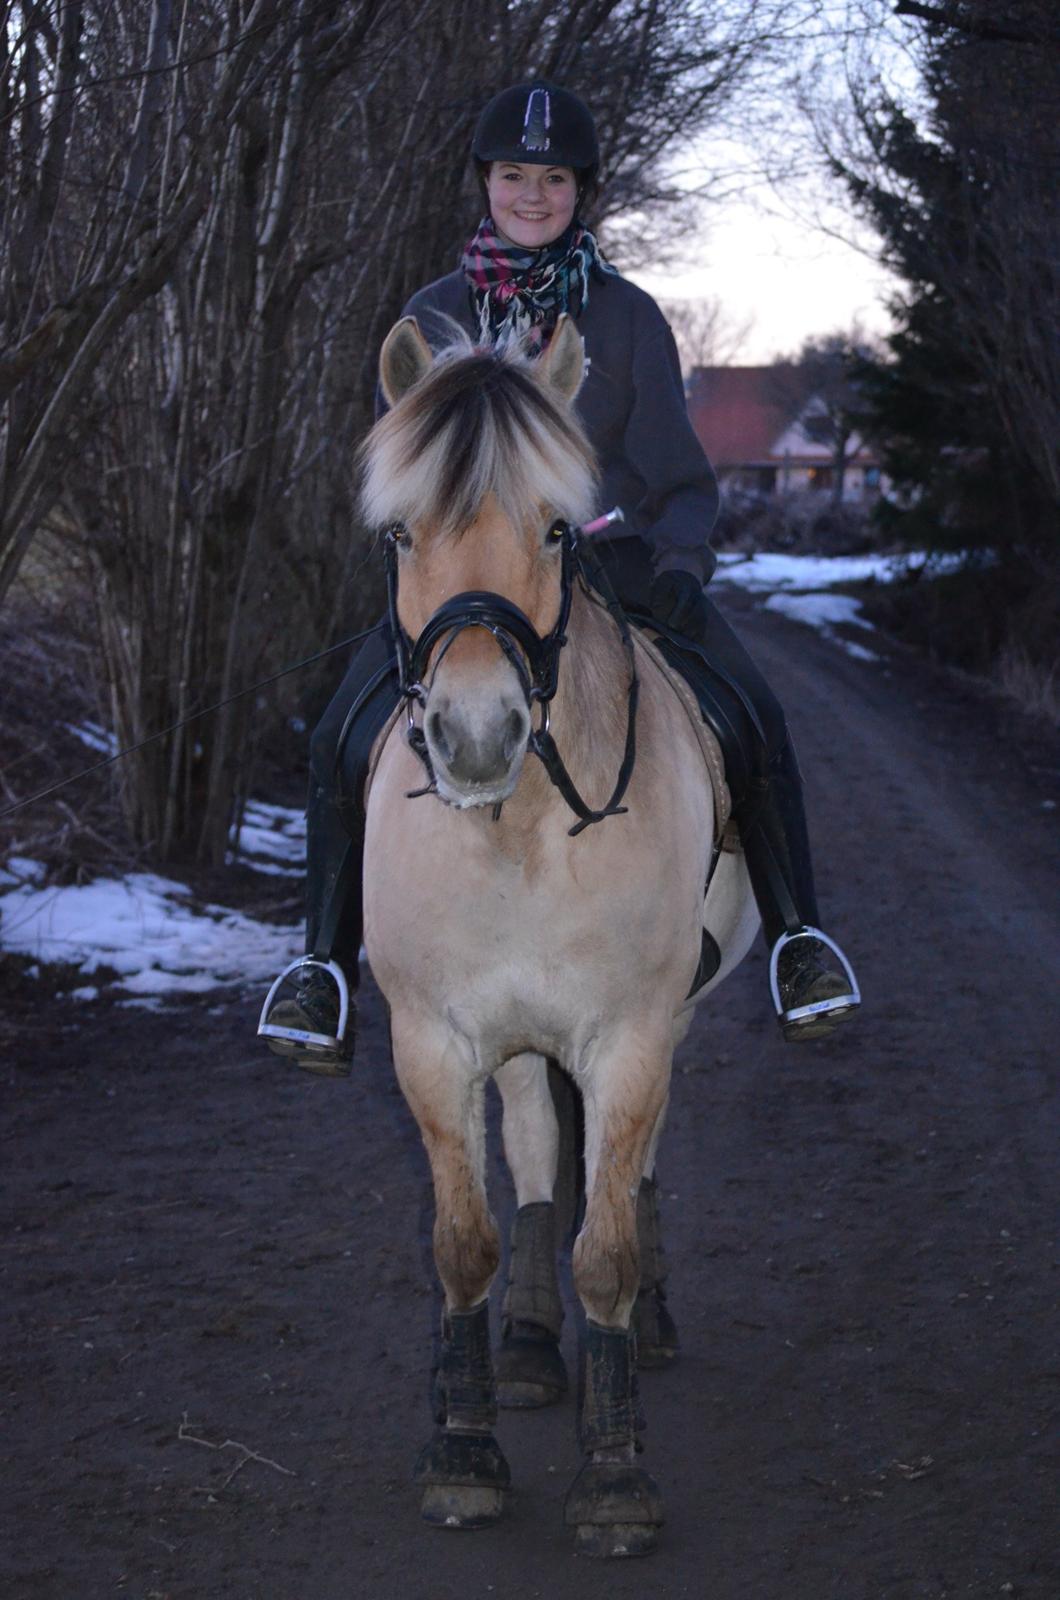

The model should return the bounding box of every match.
[496,1054,567,1410]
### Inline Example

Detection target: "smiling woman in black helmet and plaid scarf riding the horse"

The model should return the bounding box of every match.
[267,80,858,1074]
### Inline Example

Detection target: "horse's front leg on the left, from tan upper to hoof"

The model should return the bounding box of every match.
[394,1018,511,1528]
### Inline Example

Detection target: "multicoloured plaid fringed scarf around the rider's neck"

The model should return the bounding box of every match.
[460,216,618,350]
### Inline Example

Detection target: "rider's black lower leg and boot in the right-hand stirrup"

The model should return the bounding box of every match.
[737,739,860,1040]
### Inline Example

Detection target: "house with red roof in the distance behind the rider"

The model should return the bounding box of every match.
[687,365,882,502]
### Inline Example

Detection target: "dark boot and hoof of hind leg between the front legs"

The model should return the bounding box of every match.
[496,1202,568,1411]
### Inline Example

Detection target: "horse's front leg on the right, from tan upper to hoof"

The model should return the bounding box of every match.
[565,1024,671,1557]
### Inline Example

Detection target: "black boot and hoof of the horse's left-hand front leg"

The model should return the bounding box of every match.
[413,1301,511,1528]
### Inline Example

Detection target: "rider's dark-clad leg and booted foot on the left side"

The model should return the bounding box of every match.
[267,630,397,1075]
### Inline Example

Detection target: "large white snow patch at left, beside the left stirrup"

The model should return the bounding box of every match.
[0,872,303,997]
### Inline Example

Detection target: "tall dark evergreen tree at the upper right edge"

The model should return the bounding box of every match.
[836,0,1060,576]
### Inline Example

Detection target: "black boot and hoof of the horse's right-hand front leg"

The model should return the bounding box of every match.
[564,1322,663,1558]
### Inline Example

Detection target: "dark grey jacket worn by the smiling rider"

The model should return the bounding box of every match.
[404,272,717,582]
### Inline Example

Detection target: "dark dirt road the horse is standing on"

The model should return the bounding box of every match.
[0,602,1060,1600]
